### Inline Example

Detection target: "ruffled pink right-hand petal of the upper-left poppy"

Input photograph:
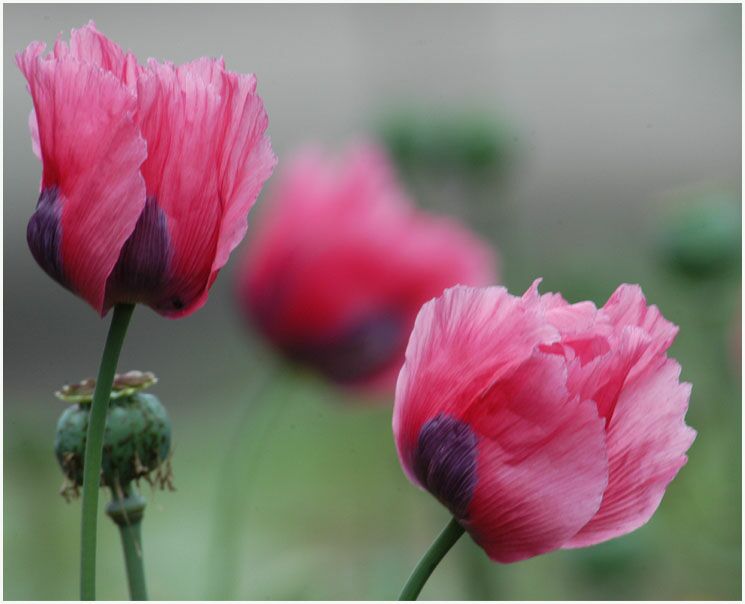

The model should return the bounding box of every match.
[132,60,276,317]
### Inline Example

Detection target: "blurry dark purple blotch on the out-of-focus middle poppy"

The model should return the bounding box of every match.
[284,312,406,384]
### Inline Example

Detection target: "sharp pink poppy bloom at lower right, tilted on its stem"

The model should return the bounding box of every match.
[393,281,696,562]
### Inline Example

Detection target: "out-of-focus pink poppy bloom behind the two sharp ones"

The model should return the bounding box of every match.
[239,145,496,389]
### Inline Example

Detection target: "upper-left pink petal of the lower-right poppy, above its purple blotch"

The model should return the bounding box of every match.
[393,286,559,484]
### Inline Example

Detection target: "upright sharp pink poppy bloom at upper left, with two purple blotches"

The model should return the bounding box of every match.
[16,22,276,317]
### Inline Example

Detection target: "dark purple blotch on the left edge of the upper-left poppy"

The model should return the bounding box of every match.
[26,187,66,285]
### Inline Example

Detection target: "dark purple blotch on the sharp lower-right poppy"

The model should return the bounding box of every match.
[413,413,477,520]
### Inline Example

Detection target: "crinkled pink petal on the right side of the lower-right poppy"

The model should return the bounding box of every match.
[567,285,696,547]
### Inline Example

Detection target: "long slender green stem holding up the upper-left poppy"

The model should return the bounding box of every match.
[80,304,134,600]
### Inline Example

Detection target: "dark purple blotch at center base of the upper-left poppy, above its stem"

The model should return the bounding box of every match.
[107,197,170,303]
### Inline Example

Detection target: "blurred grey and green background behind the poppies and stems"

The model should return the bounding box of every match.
[3,4,741,599]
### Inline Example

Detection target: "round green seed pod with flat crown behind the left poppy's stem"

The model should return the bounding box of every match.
[54,371,171,494]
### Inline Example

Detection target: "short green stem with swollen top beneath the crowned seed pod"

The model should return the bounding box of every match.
[106,487,147,600]
